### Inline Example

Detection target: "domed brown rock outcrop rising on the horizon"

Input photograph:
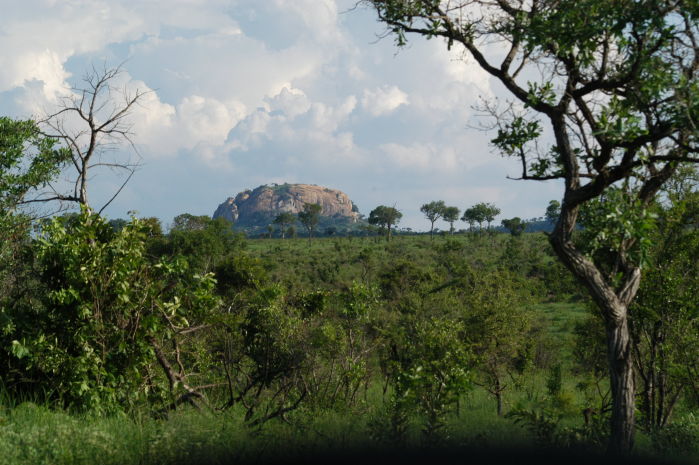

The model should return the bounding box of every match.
[213,184,359,227]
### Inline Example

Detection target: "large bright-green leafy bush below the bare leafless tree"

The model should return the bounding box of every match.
[3,210,217,411]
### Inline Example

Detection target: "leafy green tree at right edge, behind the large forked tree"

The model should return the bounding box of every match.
[631,179,699,431]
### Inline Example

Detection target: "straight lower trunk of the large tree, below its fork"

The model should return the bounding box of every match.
[607,310,636,454]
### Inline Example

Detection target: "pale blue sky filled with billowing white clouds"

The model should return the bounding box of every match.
[0,0,562,231]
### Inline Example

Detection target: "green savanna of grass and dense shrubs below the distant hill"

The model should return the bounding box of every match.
[0,213,699,464]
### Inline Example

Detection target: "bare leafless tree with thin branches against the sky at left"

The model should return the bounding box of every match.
[37,66,147,213]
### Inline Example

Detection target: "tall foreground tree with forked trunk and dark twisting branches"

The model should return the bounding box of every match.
[369,0,699,452]
